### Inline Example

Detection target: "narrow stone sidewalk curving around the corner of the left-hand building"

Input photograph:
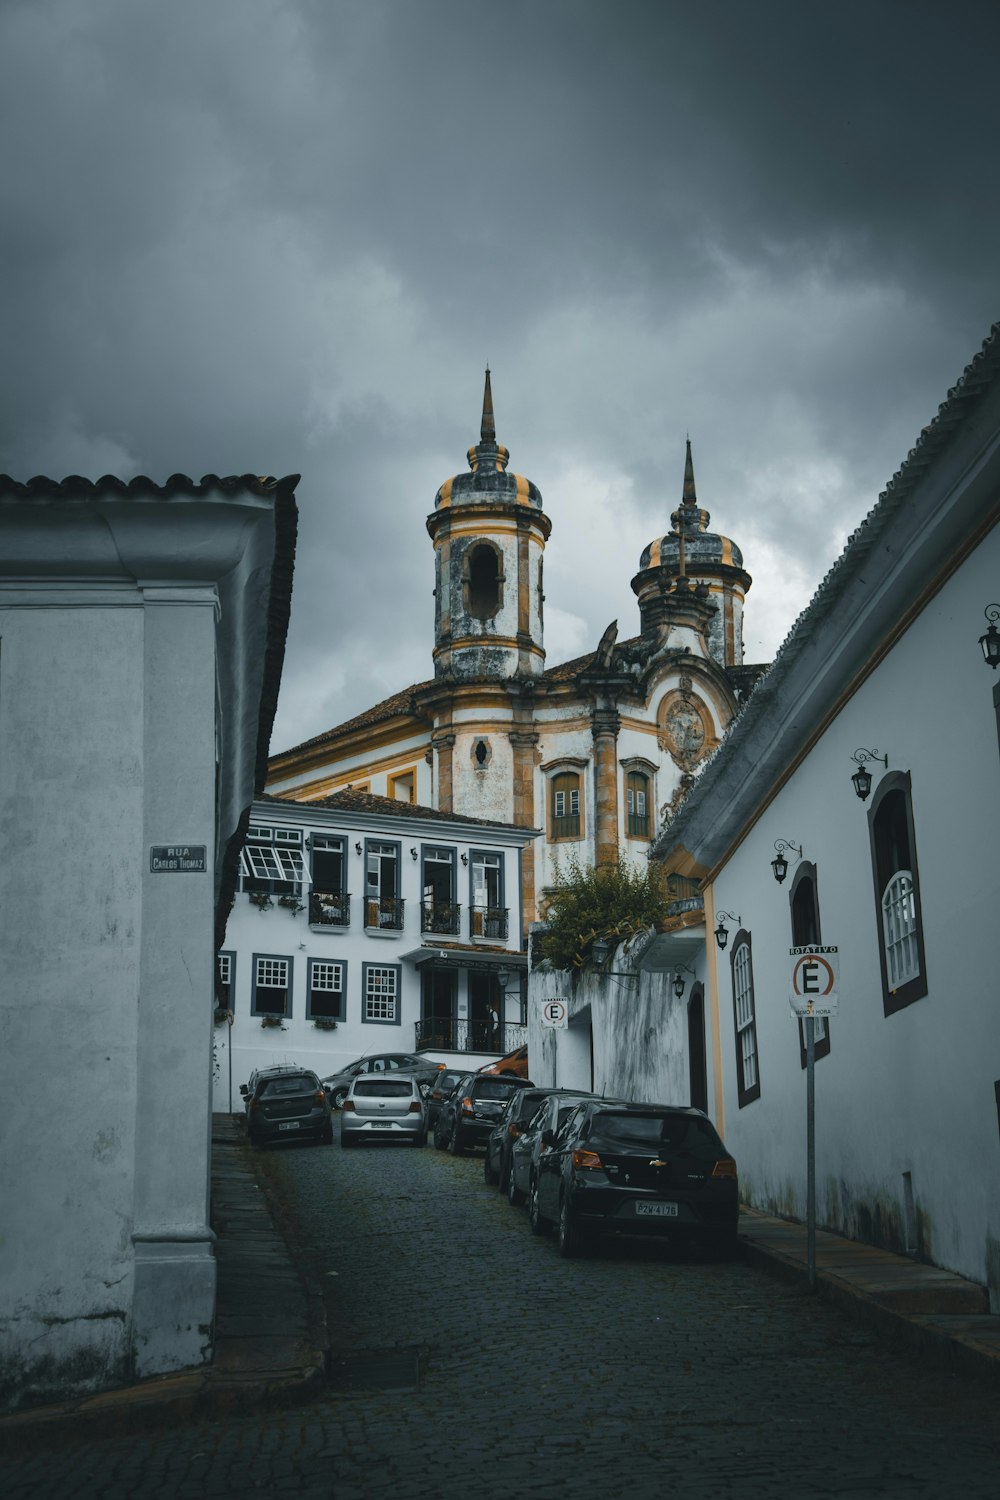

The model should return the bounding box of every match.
[0,1115,327,1451]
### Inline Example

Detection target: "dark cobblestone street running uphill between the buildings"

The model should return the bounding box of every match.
[0,1145,1000,1500]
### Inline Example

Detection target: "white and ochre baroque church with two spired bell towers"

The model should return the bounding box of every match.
[267,371,762,936]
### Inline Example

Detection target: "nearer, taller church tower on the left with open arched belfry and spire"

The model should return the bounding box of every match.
[427,369,552,681]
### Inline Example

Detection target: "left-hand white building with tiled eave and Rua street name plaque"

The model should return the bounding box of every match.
[0,476,295,1409]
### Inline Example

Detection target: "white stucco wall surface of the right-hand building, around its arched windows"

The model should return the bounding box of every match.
[714,531,1000,1296]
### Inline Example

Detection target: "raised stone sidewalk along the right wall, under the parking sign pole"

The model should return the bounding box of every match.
[739,1209,1000,1385]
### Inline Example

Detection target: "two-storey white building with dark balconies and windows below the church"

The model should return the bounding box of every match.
[214,791,537,1110]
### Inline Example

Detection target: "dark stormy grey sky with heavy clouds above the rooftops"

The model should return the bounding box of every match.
[0,0,1000,750]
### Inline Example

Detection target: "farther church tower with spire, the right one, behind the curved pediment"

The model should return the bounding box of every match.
[631,438,753,668]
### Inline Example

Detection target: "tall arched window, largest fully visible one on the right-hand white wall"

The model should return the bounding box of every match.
[868,771,927,1016]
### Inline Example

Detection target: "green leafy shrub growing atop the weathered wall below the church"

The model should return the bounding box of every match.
[538,855,667,969]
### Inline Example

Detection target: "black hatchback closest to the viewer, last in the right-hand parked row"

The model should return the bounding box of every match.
[528,1100,739,1256]
